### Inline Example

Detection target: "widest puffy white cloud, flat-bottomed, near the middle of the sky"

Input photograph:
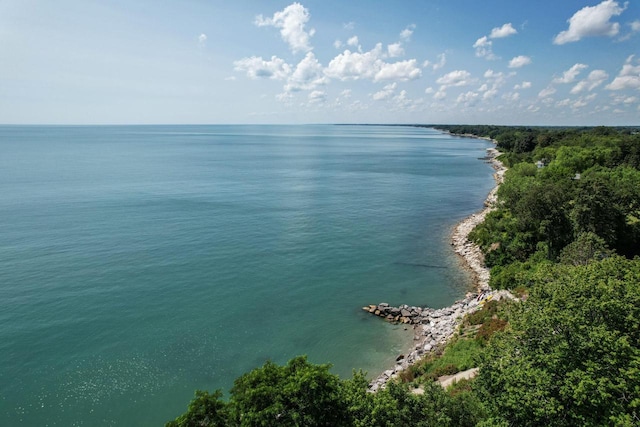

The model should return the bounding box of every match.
[324,43,422,82]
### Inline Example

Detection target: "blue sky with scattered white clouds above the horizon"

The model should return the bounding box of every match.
[0,0,640,126]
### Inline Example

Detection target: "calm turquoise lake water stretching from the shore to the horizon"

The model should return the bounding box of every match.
[0,125,493,426]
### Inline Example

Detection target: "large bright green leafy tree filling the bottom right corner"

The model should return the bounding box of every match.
[477,257,640,426]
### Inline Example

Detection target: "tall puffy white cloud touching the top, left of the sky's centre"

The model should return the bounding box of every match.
[255,3,315,53]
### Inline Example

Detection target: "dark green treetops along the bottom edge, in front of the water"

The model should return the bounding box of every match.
[167,357,484,427]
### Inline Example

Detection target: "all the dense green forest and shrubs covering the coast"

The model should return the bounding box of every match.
[167,126,640,427]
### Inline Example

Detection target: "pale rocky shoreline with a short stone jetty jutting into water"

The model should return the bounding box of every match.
[362,142,514,392]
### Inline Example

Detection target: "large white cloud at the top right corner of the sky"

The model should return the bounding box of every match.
[553,0,627,45]
